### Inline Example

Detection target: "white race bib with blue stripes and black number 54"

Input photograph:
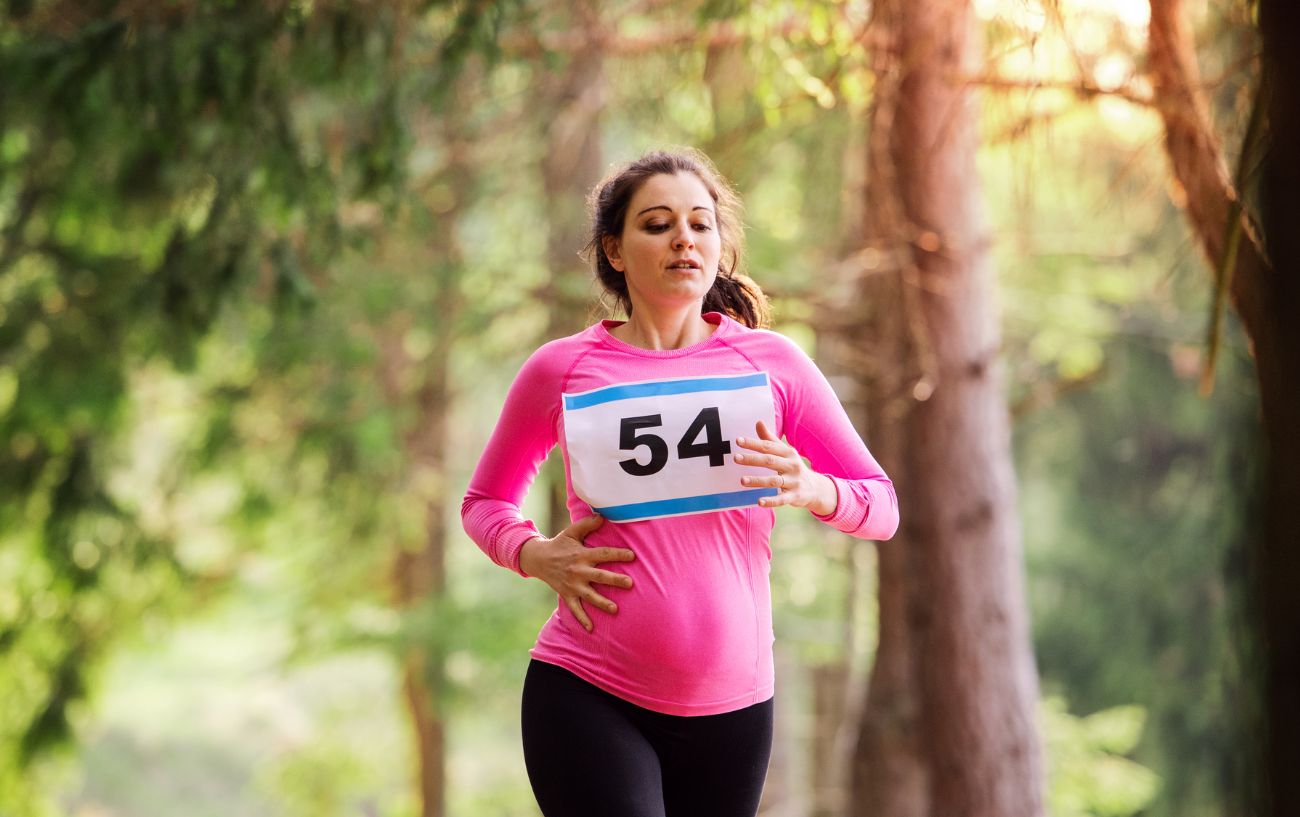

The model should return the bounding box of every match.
[564,372,777,522]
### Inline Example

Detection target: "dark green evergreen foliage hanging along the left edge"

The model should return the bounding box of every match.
[0,0,503,813]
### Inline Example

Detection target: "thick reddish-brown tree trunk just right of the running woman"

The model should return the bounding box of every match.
[857,0,1043,817]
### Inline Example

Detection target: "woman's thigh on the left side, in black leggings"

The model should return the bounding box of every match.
[521,661,664,817]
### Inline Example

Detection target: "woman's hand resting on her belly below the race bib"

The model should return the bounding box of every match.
[519,515,636,632]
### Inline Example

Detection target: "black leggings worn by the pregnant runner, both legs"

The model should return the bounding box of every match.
[523,661,772,817]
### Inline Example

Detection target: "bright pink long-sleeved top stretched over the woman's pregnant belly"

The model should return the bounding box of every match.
[460,312,898,716]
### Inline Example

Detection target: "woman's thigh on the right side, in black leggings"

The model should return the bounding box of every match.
[645,700,772,817]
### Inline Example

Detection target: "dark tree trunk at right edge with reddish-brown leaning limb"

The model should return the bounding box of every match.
[1149,0,1300,814]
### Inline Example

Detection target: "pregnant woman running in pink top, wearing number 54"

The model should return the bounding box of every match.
[462,152,898,817]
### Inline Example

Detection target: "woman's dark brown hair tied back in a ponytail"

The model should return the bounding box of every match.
[585,150,770,329]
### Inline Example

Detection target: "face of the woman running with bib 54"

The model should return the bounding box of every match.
[603,173,722,317]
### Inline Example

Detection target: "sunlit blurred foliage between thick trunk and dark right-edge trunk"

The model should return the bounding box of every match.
[980,4,1257,817]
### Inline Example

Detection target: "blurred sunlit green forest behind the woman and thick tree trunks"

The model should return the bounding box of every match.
[0,0,1294,817]
